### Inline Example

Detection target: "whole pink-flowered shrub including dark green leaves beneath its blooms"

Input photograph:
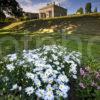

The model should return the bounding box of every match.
[77,67,100,100]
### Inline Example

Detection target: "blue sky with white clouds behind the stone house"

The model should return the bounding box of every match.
[17,0,100,14]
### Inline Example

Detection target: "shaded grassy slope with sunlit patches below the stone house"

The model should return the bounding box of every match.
[2,13,100,34]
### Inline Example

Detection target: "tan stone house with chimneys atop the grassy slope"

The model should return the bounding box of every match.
[39,3,67,18]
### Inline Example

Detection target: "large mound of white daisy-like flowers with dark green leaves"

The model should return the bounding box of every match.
[0,45,81,100]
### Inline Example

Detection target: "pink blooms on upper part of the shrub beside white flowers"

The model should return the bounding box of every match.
[79,67,100,90]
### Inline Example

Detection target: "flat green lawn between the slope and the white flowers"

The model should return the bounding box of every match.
[0,33,100,69]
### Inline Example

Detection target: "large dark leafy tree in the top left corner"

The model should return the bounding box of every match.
[0,0,23,17]
